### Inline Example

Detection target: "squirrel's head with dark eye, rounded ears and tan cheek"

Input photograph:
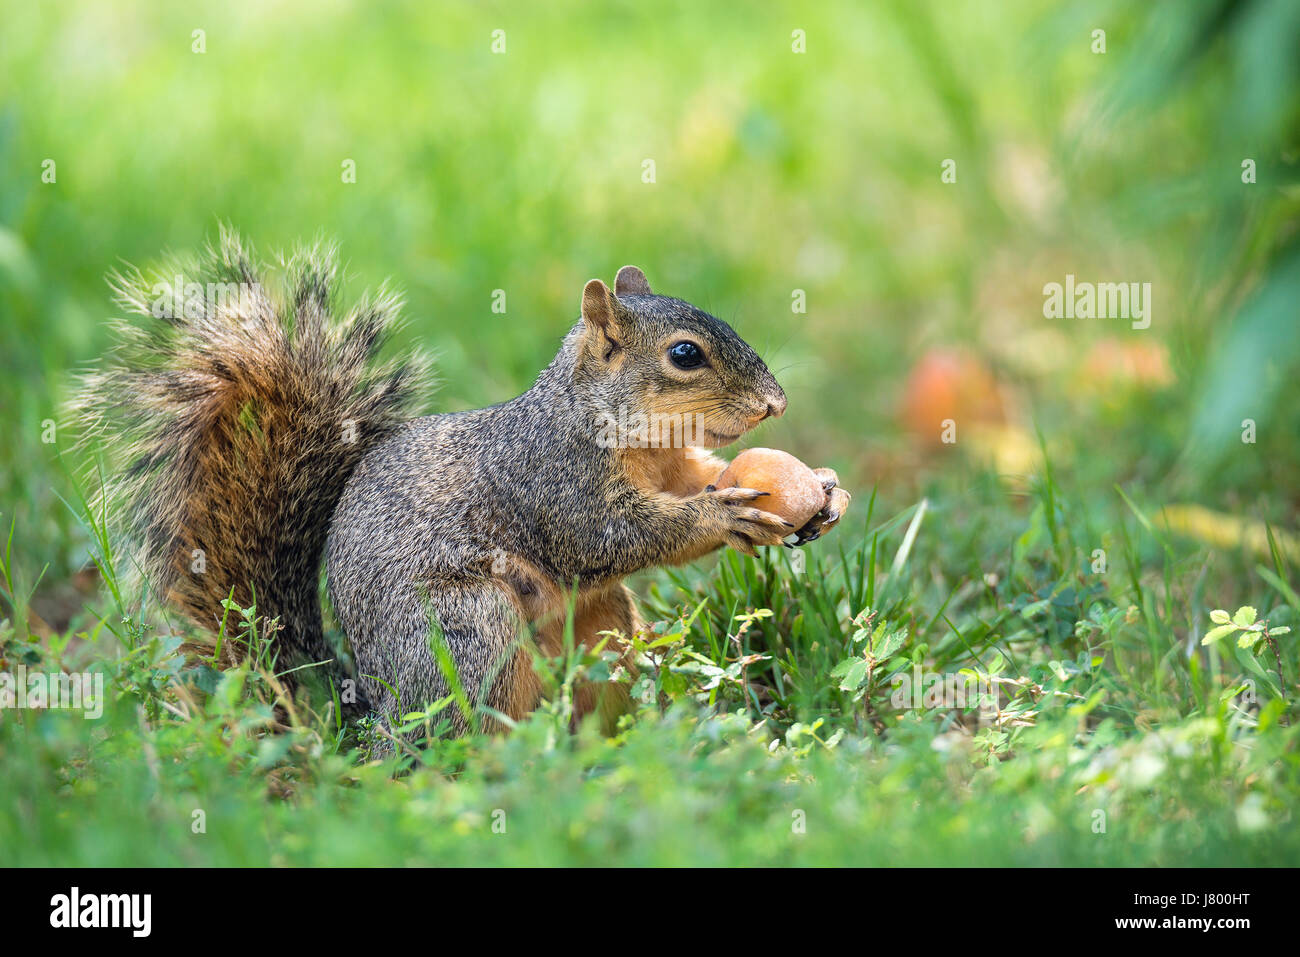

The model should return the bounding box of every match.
[573,265,785,449]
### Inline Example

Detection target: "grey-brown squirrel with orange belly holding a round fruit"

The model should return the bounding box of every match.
[79,230,849,732]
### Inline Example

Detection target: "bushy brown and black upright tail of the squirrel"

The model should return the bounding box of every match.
[78,230,423,691]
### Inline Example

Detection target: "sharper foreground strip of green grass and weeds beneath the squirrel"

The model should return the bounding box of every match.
[0,455,1300,866]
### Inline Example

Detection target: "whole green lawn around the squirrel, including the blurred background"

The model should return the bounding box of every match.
[0,0,1300,865]
